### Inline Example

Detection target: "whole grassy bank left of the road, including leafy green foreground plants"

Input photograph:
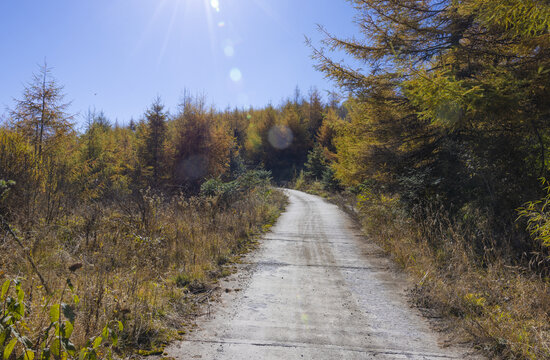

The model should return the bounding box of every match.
[0,179,286,360]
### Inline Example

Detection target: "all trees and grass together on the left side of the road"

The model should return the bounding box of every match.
[0,59,337,359]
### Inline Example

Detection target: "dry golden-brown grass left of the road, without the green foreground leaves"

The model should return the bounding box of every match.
[0,188,286,356]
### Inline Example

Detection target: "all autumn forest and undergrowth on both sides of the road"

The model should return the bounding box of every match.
[0,0,550,360]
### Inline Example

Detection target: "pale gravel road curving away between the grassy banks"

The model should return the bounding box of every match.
[167,190,477,360]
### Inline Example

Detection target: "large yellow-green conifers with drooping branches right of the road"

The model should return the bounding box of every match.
[313,0,550,229]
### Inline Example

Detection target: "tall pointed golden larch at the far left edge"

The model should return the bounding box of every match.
[1,64,75,222]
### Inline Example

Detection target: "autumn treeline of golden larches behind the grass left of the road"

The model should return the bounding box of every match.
[0,66,338,226]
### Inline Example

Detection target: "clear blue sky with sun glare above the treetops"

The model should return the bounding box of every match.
[0,0,356,123]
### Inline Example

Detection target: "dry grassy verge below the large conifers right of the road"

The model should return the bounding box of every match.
[301,184,550,359]
